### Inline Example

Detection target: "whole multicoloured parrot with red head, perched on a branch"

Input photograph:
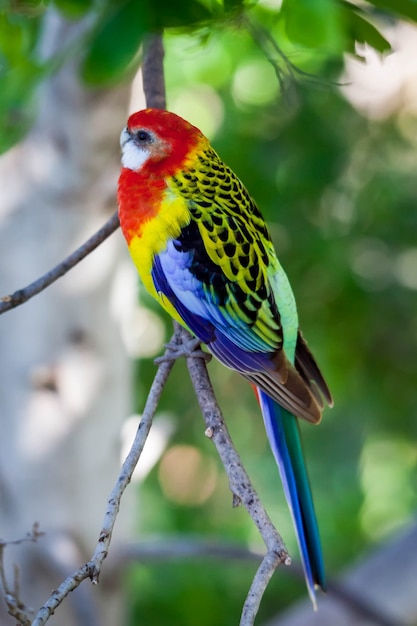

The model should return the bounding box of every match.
[117,108,333,607]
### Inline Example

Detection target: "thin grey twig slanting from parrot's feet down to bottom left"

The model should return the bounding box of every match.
[32,354,174,626]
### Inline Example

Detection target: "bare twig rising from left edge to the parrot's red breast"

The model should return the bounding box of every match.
[0,213,119,315]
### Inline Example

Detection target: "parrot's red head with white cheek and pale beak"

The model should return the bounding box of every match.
[120,109,207,177]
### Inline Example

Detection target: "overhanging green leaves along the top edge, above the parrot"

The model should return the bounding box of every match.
[0,0,410,153]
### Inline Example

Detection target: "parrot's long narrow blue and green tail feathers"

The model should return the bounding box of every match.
[258,389,325,607]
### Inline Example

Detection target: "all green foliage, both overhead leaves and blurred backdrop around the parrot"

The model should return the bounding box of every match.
[0,0,417,626]
